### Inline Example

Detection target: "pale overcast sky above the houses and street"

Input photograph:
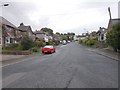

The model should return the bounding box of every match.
[0,0,119,34]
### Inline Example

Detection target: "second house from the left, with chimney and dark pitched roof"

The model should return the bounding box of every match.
[17,23,35,40]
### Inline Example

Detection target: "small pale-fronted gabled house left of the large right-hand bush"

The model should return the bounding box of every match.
[97,27,108,42]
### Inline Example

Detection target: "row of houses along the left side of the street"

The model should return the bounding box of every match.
[0,16,53,45]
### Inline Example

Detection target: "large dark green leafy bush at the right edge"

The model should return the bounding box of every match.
[106,23,120,52]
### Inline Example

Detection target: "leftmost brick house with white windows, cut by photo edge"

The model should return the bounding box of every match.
[0,16,18,46]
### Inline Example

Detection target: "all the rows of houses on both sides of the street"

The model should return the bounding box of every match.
[0,16,120,45]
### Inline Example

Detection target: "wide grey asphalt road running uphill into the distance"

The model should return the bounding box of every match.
[2,42,118,88]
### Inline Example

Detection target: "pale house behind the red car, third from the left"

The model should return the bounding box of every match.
[34,30,49,42]
